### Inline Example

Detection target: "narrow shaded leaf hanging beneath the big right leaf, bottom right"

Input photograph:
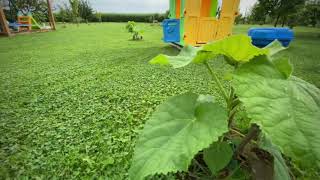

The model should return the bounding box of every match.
[259,136,291,180]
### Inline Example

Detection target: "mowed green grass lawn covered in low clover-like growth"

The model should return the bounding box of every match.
[0,23,320,180]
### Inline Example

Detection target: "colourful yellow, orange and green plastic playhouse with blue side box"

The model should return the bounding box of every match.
[162,0,240,46]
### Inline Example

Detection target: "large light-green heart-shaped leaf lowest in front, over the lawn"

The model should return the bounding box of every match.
[129,93,228,180]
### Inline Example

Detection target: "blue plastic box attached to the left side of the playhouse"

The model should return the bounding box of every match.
[162,19,180,43]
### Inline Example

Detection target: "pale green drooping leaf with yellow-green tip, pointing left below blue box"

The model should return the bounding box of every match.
[150,46,200,68]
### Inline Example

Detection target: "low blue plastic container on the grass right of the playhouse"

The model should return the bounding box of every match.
[248,28,294,47]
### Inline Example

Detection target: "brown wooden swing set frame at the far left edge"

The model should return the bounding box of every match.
[0,0,56,36]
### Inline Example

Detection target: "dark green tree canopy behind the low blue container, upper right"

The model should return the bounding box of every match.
[248,0,320,27]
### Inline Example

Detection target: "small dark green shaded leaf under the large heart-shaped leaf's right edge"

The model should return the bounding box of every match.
[203,142,233,174]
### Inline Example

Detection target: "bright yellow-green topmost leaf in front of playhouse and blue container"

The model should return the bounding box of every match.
[193,35,269,65]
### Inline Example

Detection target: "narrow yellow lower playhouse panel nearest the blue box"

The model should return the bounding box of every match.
[183,17,198,46]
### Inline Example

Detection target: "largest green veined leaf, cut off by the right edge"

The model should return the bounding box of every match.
[233,56,320,168]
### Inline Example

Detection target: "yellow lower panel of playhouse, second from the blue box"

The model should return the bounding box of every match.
[197,17,218,44]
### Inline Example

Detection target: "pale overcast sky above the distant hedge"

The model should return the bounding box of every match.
[56,0,257,14]
